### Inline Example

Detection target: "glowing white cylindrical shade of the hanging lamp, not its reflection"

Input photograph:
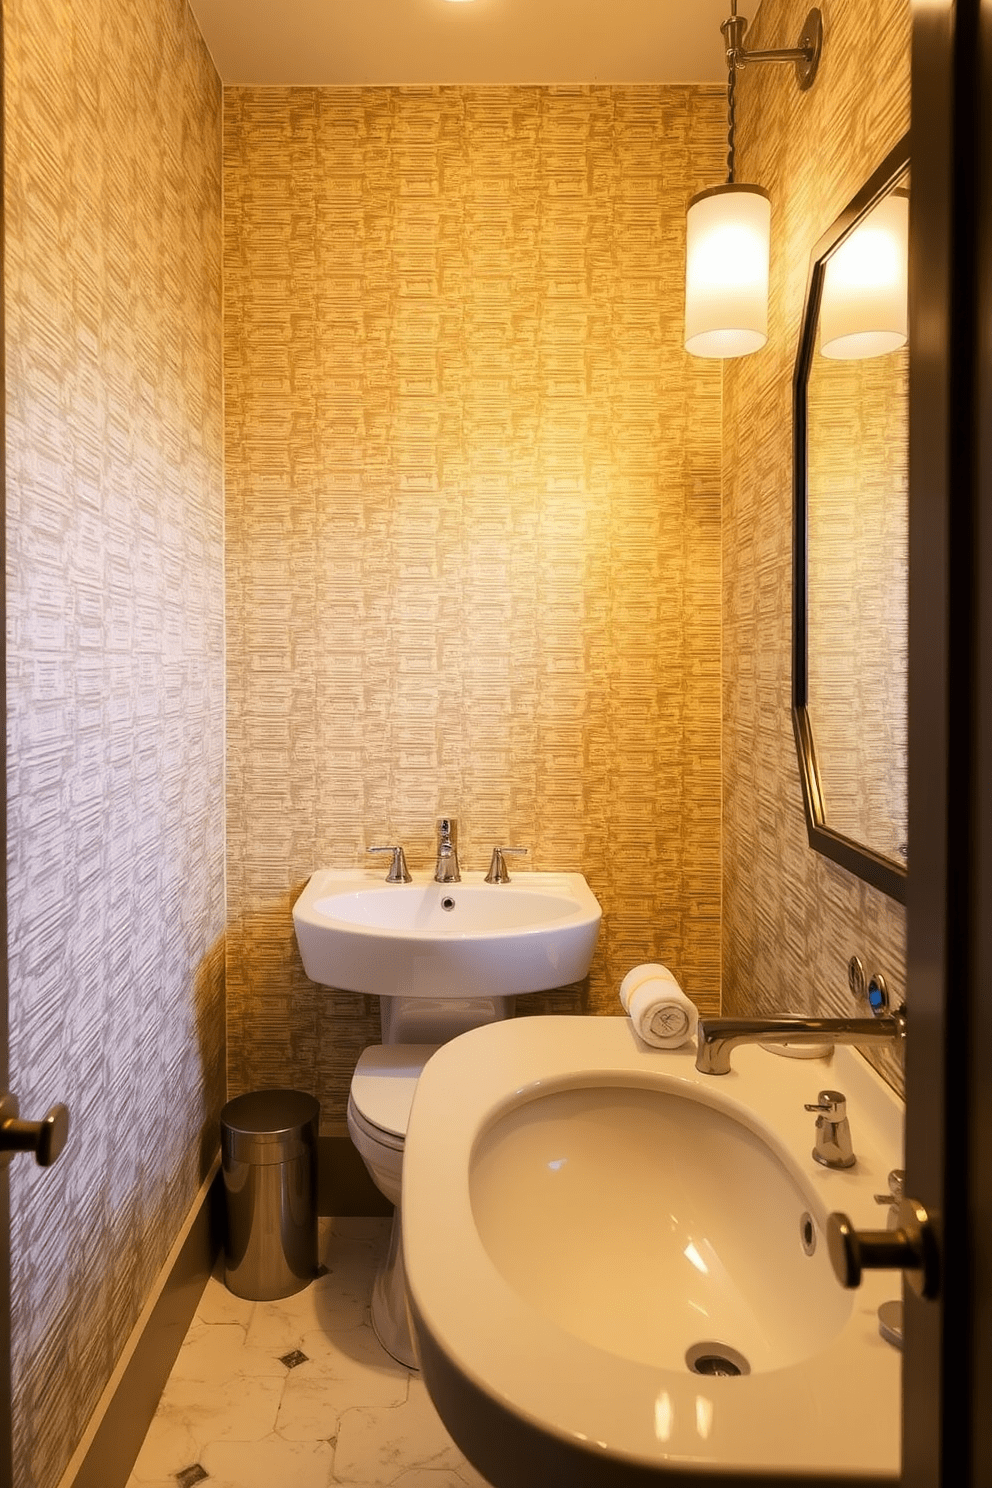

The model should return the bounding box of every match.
[686,185,772,357]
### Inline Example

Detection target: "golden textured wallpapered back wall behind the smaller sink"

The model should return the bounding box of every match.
[225,78,723,1119]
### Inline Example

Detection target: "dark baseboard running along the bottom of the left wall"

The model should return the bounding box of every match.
[58,1153,223,1488]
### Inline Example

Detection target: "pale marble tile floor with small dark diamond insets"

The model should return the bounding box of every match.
[128,1219,486,1488]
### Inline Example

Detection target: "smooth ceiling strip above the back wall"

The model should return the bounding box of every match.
[189,0,734,86]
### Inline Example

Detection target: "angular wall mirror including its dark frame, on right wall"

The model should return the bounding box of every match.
[793,135,909,902]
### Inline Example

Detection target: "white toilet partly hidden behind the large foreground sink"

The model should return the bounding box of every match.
[348,997,515,1369]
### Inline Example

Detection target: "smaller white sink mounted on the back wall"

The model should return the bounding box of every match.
[293,869,602,998]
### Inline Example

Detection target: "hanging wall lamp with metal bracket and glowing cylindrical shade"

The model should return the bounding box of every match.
[686,0,822,357]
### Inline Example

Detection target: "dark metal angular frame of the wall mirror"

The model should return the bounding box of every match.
[793,134,910,903]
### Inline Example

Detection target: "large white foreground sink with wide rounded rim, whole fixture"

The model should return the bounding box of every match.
[403,1018,901,1488]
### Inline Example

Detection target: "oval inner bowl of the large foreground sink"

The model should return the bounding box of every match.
[468,1083,851,1370]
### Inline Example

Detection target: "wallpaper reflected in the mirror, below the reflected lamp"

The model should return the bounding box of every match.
[806,242,909,862]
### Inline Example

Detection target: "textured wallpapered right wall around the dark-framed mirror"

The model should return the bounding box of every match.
[723,0,910,1083]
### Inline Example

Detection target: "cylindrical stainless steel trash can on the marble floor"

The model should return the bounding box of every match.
[220,1091,320,1302]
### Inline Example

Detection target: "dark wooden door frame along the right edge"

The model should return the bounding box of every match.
[903,0,992,1488]
